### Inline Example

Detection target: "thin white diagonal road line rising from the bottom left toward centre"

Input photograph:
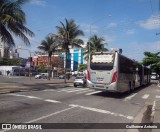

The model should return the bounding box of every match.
[25,106,76,123]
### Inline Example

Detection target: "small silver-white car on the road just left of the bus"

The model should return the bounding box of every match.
[73,76,87,87]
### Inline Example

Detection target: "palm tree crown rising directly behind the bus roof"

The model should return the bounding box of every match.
[84,35,108,60]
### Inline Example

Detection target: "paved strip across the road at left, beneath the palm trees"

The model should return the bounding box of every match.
[0,76,73,94]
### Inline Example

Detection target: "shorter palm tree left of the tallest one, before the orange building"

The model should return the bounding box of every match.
[38,34,59,80]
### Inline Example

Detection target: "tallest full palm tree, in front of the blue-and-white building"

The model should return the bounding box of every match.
[56,19,84,83]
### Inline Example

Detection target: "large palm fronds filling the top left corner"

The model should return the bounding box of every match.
[0,0,34,46]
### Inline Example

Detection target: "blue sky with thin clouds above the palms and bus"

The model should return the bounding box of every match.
[17,0,160,61]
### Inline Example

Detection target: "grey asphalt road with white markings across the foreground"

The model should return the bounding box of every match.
[0,79,160,132]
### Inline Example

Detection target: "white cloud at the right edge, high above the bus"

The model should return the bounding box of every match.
[137,16,160,30]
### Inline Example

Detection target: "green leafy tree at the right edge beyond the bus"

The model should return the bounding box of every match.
[142,51,160,74]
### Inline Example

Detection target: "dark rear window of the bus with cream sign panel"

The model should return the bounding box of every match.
[90,53,115,70]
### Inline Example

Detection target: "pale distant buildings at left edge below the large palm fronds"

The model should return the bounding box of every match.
[0,43,19,59]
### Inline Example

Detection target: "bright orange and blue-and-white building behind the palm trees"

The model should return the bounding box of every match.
[33,48,86,71]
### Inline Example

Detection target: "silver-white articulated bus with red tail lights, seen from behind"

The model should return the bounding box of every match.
[87,50,150,93]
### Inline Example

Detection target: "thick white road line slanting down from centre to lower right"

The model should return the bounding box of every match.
[69,104,134,120]
